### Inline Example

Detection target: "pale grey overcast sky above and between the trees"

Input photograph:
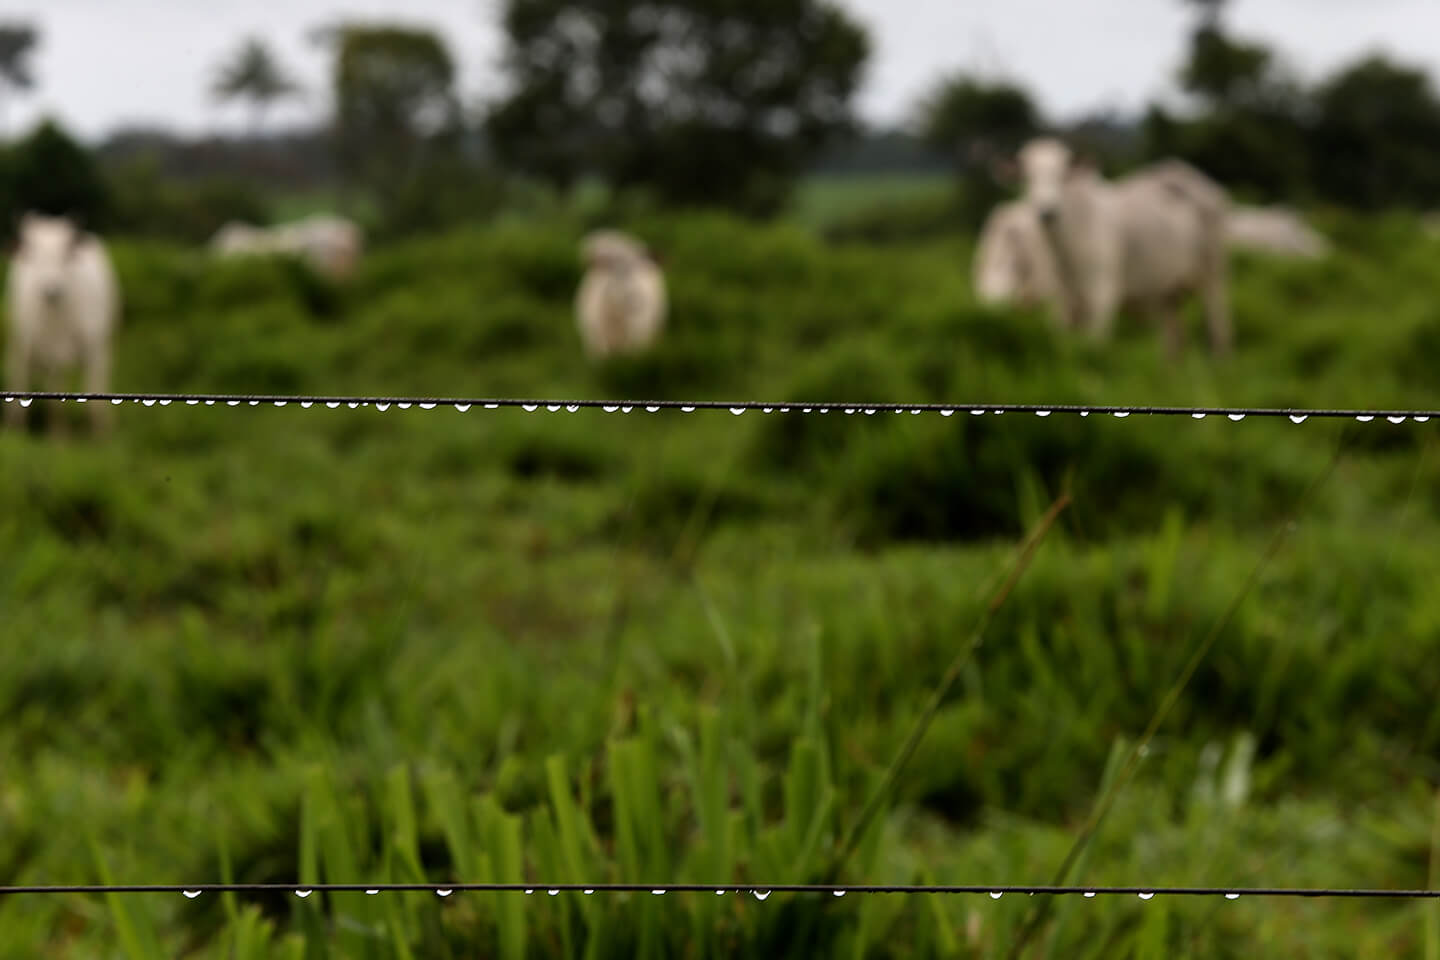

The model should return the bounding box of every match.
[0,0,1440,138]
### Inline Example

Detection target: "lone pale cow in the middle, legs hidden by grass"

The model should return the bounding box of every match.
[575,230,667,360]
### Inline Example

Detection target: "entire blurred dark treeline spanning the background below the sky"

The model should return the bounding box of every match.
[0,0,1440,240]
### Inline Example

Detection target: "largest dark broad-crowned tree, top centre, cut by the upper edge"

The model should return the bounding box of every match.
[487,0,870,214]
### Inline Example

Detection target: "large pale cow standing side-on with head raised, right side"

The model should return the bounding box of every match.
[999,137,1231,357]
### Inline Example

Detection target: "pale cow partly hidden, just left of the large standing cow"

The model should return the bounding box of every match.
[972,201,1058,307]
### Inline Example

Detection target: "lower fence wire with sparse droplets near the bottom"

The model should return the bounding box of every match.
[0,884,1440,900]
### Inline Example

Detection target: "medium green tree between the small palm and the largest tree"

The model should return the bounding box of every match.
[324,24,464,223]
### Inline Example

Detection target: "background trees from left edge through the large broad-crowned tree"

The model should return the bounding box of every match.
[0,0,870,247]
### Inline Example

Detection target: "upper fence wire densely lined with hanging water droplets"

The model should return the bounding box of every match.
[0,390,1440,423]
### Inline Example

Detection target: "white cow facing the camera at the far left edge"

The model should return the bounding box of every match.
[4,213,120,433]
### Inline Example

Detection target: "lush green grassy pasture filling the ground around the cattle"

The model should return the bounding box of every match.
[0,191,1440,960]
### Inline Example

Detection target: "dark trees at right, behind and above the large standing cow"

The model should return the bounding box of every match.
[919,0,1440,227]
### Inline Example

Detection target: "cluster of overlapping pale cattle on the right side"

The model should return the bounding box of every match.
[973,137,1329,357]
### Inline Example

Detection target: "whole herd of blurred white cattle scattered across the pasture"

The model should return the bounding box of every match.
[4,137,1359,430]
